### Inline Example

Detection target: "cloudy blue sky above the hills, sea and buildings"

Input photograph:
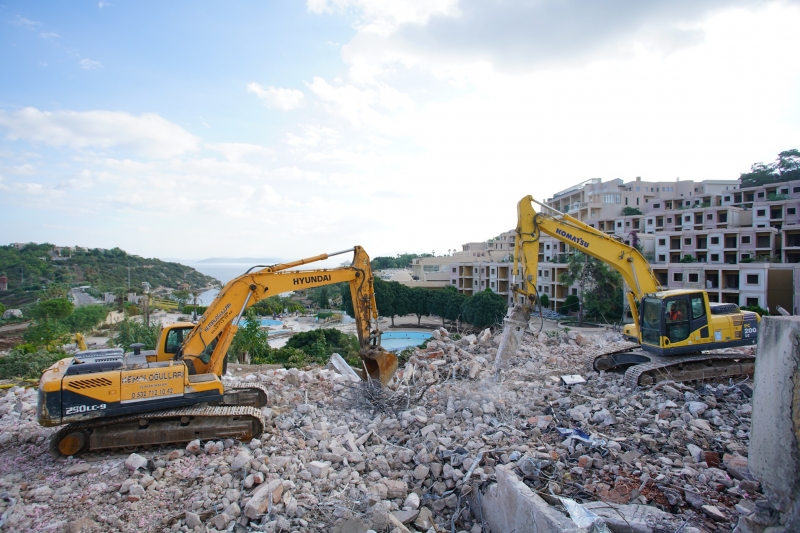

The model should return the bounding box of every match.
[0,0,800,259]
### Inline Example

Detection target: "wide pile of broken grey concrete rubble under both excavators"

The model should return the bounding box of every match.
[0,330,763,533]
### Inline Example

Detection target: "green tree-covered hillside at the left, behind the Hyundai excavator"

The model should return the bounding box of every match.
[0,243,219,301]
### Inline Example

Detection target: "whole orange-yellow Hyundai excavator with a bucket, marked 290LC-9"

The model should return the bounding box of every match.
[37,246,397,456]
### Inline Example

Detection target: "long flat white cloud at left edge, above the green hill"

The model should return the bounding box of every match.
[0,107,198,157]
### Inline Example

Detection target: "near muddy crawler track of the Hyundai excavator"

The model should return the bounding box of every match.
[50,405,267,456]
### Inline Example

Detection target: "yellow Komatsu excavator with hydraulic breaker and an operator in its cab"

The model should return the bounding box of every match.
[497,196,761,387]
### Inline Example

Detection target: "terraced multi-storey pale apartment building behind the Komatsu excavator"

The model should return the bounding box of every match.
[412,178,800,314]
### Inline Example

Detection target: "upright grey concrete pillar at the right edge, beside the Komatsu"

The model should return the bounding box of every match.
[747,316,800,531]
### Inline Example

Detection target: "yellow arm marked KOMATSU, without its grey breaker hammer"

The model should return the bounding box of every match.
[514,196,661,329]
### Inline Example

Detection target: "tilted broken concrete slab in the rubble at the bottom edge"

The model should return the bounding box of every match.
[481,465,585,533]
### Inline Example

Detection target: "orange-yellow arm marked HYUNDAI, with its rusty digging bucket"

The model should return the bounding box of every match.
[177,246,397,385]
